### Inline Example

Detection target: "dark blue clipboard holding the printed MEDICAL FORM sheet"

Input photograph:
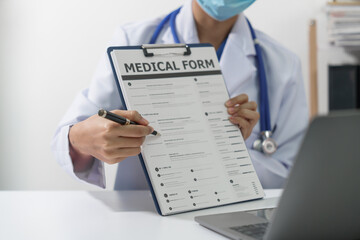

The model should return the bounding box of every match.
[108,44,264,215]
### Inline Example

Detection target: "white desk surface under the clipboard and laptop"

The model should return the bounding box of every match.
[0,190,281,240]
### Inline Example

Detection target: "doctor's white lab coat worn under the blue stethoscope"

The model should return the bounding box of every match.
[52,0,308,189]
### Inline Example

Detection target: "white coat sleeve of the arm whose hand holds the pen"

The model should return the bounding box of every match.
[51,28,128,188]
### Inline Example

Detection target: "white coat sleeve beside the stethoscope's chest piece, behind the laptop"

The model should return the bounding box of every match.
[246,58,308,188]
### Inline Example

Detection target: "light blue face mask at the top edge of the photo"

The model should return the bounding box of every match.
[197,0,255,21]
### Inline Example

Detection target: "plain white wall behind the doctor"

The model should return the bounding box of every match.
[0,0,326,190]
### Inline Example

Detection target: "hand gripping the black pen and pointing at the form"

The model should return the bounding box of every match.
[68,110,159,172]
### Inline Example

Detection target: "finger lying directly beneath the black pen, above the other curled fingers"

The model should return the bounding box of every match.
[103,121,154,140]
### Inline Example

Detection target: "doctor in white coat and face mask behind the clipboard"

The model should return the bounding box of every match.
[52,0,308,189]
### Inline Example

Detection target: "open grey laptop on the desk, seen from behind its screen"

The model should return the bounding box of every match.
[195,111,360,240]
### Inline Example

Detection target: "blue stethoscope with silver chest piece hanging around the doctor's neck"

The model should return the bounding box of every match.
[149,8,277,155]
